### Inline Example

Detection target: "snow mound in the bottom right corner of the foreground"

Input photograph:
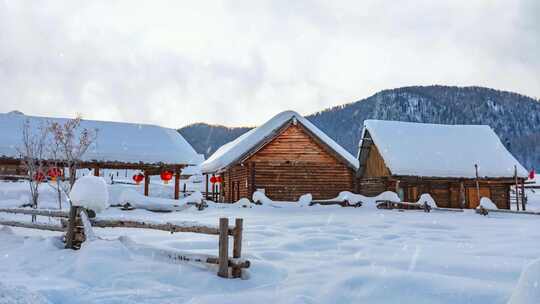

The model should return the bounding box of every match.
[508,259,540,304]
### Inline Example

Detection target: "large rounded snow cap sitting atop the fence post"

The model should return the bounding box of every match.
[69,176,109,213]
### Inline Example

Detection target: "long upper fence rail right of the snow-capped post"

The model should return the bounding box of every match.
[90,219,229,235]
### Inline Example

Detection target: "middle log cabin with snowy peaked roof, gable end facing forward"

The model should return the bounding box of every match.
[201,111,358,202]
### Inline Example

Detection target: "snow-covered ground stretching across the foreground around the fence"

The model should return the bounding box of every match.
[0,184,540,303]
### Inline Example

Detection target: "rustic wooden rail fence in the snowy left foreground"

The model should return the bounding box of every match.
[0,206,251,278]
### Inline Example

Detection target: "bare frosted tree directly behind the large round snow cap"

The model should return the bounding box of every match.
[48,116,97,193]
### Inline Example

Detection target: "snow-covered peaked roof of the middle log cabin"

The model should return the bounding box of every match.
[201,111,358,173]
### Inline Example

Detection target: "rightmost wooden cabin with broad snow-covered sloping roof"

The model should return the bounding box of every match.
[356,120,527,209]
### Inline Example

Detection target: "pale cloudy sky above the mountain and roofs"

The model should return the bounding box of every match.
[0,0,540,127]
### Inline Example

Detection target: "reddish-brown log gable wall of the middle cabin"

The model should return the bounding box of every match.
[219,124,355,202]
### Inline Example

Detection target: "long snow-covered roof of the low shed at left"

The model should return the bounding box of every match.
[0,112,204,165]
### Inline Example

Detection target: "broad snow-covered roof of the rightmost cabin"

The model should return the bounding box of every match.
[360,120,527,178]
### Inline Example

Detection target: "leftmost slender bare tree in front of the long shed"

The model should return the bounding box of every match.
[17,119,48,208]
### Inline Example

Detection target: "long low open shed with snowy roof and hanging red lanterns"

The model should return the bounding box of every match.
[0,112,204,198]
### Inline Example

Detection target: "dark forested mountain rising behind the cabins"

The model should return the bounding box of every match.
[179,85,540,168]
